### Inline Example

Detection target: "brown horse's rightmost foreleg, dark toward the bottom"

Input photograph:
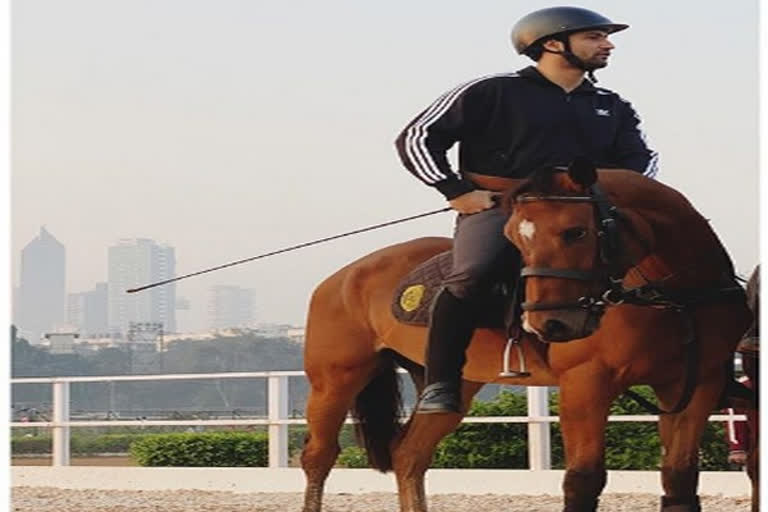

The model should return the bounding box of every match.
[656,373,725,512]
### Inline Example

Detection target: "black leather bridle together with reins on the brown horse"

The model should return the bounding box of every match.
[516,183,744,414]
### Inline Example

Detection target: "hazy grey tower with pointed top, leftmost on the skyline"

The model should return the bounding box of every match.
[16,227,66,343]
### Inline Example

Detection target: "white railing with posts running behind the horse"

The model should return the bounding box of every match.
[10,370,746,470]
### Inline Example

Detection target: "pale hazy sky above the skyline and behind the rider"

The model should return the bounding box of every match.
[11,0,758,329]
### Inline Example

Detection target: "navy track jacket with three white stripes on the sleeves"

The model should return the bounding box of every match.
[396,66,658,200]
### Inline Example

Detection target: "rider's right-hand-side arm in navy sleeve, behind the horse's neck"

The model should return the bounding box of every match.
[611,98,659,178]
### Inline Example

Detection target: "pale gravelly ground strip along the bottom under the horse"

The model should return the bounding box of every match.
[11,487,749,512]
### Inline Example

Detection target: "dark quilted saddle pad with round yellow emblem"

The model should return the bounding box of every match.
[391,251,508,328]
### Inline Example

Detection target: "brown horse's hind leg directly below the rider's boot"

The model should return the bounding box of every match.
[392,381,483,512]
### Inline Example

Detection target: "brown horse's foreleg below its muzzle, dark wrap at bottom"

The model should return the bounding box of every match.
[560,364,618,512]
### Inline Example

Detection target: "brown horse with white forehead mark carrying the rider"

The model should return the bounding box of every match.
[302,166,751,512]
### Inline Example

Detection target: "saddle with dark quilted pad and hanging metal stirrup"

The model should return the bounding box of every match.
[391,251,530,377]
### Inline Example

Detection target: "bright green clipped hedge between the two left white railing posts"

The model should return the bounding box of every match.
[131,432,268,467]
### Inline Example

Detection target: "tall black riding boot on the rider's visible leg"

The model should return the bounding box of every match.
[416,289,475,414]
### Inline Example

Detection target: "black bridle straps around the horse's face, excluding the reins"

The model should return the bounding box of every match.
[516,183,624,313]
